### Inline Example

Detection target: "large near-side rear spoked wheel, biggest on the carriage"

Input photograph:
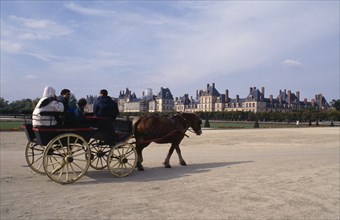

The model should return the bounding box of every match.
[43,133,90,184]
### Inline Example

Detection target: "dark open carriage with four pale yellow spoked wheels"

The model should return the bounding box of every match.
[23,112,137,184]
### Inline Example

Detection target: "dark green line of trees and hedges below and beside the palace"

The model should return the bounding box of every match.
[0,97,340,122]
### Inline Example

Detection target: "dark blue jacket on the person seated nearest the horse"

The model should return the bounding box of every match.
[93,96,119,119]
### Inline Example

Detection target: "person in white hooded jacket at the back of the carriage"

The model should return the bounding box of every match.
[32,86,64,127]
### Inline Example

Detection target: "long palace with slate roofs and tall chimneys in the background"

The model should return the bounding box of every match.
[87,83,329,113]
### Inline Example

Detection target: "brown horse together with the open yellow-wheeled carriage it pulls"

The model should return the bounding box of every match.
[24,112,202,184]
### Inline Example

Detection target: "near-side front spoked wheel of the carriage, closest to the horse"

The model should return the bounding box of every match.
[107,142,137,177]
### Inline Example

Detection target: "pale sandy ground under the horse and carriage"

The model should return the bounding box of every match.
[0,127,340,220]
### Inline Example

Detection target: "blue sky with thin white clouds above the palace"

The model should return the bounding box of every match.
[0,0,340,101]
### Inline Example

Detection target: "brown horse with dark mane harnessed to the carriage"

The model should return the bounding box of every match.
[132,113,202,170]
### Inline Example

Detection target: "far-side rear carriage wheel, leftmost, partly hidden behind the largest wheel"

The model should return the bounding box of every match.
[25,141,45,174]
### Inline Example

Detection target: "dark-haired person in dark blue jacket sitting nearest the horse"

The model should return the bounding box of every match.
[93,89,119,142]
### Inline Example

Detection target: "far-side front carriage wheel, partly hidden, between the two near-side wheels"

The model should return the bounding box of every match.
[89,139,111,170]
